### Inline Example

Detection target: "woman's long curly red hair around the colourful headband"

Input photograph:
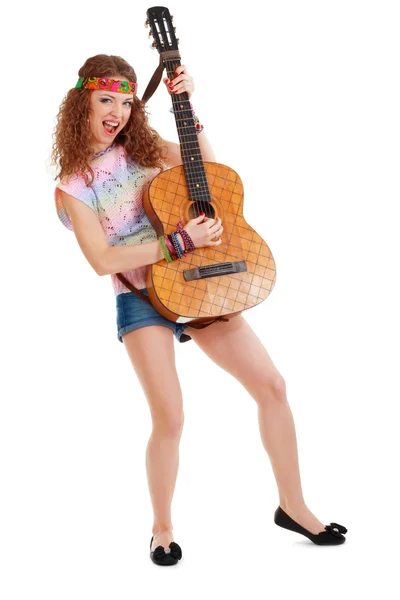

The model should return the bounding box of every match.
[51,54,167,186]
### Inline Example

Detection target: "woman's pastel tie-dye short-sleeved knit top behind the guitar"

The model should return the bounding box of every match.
[55,145,160,296]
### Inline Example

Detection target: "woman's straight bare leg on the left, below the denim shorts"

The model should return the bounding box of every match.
[122,326,184,550]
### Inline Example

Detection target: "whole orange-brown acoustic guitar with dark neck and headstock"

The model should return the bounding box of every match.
[118,6,276,327]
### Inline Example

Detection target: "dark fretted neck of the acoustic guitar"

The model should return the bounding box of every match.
[164,59,211,202]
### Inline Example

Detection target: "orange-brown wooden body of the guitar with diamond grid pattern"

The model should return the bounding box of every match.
[143,162,276,323]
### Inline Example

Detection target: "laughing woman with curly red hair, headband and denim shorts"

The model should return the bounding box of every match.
[52,55,347,565]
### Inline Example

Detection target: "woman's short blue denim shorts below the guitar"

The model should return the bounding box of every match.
[116,288,192,343]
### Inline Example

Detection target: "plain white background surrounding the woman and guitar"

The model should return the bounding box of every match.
[0,0,400,600]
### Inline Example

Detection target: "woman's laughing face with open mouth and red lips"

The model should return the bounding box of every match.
[89,75,133,153]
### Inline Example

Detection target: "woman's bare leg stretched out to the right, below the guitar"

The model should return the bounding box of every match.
[190,315,324,533]
